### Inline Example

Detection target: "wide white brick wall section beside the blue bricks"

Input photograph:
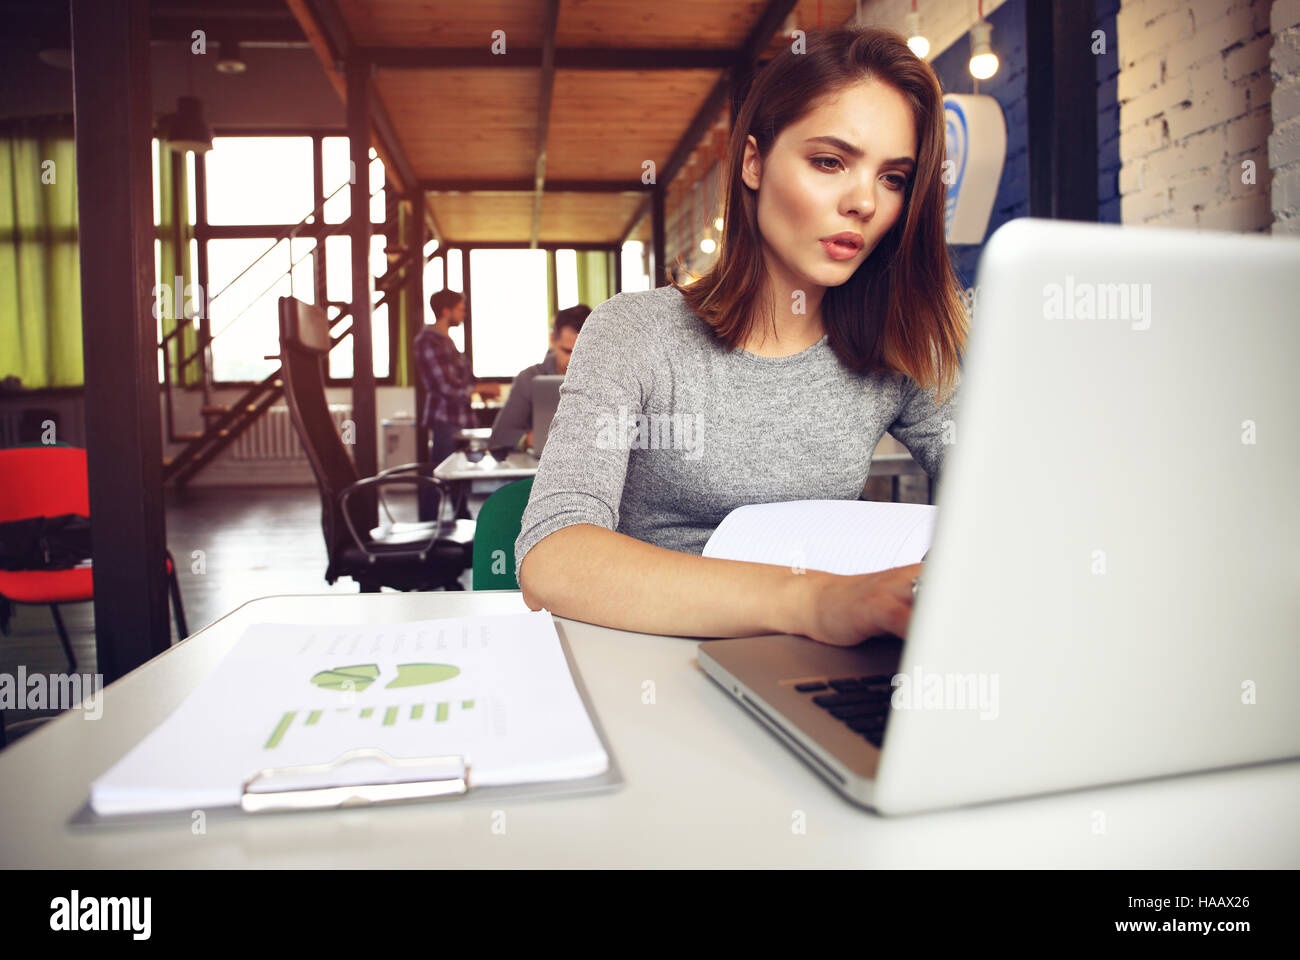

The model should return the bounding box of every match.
[1115,0,1274,232]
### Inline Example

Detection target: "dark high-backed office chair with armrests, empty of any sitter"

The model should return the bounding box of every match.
[280,297,475,593]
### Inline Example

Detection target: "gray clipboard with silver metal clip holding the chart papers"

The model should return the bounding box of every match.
[68,619,623,830]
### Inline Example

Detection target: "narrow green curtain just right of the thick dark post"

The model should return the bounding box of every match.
[155,140,198,386]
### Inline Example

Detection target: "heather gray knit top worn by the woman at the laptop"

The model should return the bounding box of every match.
[515,286,958,570]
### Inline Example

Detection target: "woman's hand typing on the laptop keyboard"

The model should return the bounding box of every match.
[798,563,924,647]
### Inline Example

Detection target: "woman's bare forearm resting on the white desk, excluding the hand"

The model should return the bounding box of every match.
[519,524,828,636]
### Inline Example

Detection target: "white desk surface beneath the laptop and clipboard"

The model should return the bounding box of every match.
[0,591,1300,868]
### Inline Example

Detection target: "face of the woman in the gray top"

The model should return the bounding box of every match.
[741,79,917,289]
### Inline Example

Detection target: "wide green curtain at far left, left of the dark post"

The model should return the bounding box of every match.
[0,118,85,390]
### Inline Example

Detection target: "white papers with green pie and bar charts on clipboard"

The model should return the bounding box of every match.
[91,610,610,814]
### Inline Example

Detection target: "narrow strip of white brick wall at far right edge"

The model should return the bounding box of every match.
[1260,0,1300,234]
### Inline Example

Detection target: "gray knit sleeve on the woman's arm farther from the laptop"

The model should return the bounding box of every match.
[515,294,647,570]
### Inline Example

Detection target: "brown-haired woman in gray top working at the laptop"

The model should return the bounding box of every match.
[515,29,967,645]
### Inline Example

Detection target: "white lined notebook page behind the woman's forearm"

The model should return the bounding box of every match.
[703,500,939,575]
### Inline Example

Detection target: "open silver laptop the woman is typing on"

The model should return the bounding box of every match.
[698,219,1300,814]
